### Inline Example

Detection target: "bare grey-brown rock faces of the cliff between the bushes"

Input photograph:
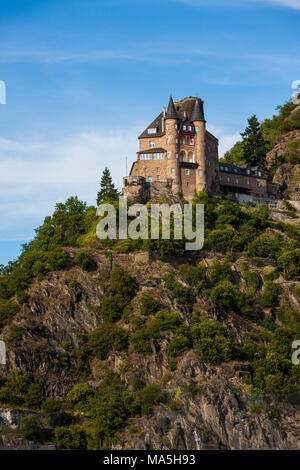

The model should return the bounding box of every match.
[0,248,300,449]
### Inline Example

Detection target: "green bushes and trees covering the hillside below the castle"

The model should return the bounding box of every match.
[0,167,300,449]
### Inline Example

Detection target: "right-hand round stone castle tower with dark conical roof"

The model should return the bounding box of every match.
[191,99,207,191]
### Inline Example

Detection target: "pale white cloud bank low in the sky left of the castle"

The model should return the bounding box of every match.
[0,126,142,239]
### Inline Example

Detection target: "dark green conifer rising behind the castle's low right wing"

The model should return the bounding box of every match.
[241,114,267,168]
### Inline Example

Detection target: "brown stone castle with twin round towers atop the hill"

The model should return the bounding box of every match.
[123,97,280,203]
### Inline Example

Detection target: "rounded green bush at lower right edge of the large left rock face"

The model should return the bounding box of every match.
[88,323,128,360]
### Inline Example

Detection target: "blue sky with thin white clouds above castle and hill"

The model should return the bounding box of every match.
[0,0,300,264]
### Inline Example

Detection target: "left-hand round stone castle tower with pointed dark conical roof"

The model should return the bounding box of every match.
[165,96,181,194]
